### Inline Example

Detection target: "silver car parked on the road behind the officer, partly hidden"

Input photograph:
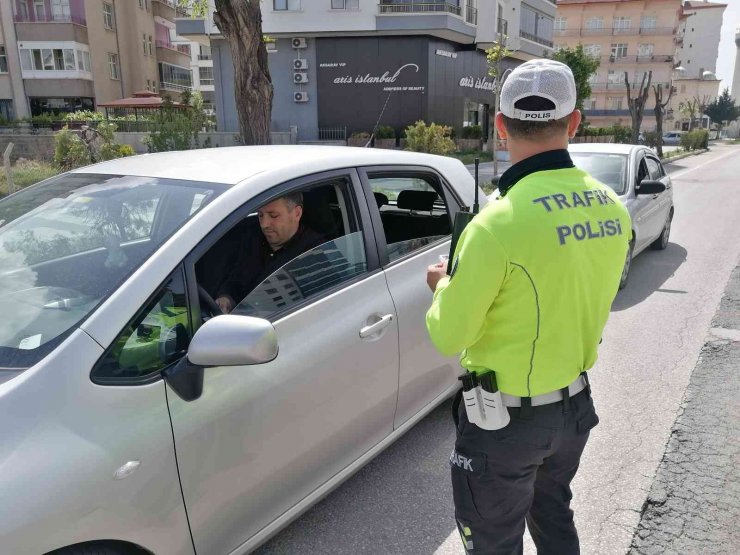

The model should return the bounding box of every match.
[568,143,674,289]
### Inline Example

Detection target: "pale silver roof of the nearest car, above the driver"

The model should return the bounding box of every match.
[74,145,464,185]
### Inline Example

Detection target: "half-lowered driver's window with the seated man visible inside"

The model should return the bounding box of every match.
[195,176,367,318]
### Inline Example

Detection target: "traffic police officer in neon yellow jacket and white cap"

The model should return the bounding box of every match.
[427,60,631,555]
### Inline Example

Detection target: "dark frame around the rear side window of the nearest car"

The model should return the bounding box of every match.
[358,165,464,268]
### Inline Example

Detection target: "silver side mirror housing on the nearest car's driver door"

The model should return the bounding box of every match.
[187,314,278,367]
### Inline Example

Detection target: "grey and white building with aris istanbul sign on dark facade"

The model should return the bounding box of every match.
[177,0,555,141]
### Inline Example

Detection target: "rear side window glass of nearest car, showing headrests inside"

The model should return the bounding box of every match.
[368,172,451,262]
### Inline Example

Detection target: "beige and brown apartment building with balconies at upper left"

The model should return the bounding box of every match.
[0,0,192,119]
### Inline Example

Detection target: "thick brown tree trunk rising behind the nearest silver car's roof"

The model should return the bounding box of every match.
[213,0,273,145]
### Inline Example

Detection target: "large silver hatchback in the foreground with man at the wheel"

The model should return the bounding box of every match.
[0,146,485,555]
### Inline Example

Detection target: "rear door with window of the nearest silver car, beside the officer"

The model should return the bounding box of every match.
[360,167,461,428]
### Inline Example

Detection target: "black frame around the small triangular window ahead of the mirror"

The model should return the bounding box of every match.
[90,263,192,387]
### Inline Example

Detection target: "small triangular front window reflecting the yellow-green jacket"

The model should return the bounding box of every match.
[92,269,191,384]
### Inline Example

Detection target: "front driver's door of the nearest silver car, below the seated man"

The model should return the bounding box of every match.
[168,170,399,554]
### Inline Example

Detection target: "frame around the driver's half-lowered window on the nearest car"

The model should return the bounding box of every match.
[184,167,382,328]
